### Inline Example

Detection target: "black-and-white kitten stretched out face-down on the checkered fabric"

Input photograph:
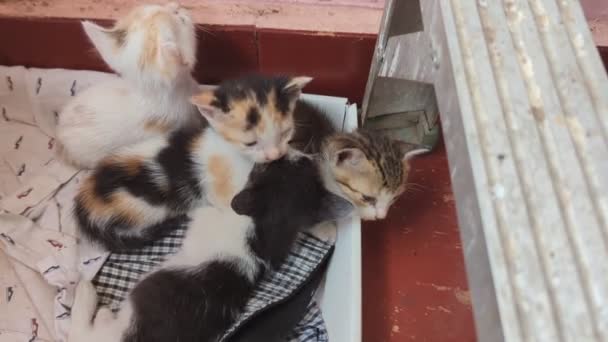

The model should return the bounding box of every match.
[70,154,353,342]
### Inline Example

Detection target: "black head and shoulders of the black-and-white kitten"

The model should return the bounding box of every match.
[232,157,352,268]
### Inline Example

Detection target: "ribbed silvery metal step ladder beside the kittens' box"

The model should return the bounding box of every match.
[364,0,608,341]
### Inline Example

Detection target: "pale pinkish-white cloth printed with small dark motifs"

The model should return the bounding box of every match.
[0,66,116,342]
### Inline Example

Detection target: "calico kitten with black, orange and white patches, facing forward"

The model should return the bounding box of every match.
[75,76,311,251]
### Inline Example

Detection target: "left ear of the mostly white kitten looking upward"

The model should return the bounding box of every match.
[82,20,126,70]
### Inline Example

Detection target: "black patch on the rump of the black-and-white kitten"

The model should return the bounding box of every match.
[123,260,253,342]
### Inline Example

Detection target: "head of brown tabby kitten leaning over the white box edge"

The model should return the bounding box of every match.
[319,129,429,220]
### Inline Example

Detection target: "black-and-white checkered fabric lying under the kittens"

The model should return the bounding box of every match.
[93,226,333,342]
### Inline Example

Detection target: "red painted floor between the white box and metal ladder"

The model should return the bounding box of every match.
[363,140,475,342]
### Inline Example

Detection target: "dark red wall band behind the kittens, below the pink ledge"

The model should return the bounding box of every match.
[0,17,376,104]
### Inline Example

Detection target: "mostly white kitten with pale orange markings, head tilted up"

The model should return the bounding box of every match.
[56,3,201,168]
